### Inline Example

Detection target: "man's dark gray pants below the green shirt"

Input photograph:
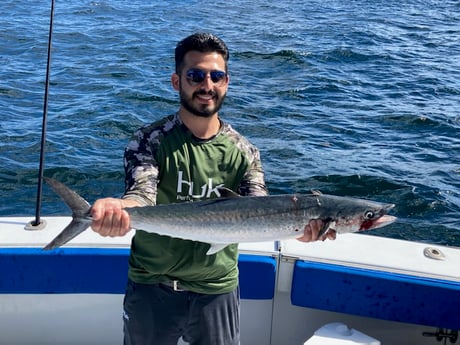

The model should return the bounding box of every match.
[123,281,240,345]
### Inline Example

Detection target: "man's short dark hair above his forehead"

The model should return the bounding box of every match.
[175,32,230,73]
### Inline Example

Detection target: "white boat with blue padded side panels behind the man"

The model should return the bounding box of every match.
[0,216,460,345]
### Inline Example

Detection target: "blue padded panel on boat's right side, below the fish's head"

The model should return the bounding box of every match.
[291,261,460,329]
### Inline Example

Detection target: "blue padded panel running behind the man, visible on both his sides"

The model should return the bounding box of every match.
[0,248,276,299]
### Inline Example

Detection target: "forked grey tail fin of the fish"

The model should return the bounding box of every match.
[43,177,91,250]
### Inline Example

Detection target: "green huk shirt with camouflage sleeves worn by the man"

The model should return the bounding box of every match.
[124,114,267,294]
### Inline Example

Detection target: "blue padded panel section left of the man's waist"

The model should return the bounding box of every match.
[0,248,129,294]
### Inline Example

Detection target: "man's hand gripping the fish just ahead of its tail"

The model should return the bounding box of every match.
[91,198,134,237]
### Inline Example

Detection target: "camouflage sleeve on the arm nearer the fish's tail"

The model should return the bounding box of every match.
[123,128,159,206]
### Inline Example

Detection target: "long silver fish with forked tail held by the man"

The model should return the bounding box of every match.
[43,177,396,255]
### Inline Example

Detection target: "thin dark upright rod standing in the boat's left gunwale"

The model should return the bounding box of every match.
[25,0,54,230]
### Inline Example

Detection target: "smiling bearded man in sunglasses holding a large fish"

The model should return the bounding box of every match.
[92,33,335,345]
